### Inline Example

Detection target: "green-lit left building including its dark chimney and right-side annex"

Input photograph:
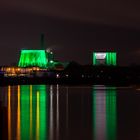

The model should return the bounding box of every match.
[18,33,54,68]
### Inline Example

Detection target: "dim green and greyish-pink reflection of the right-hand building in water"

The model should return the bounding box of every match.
[93,87,116,140]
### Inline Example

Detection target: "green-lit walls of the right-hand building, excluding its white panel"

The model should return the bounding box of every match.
[92,52,117,66]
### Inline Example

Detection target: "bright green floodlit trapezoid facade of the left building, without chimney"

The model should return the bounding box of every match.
[18,50,48,68]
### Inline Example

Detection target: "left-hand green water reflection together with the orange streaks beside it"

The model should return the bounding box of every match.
[7,85,48,140]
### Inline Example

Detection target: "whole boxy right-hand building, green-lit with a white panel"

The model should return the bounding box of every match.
[93,52,117,66]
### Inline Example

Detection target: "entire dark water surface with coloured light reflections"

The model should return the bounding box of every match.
[0,85,140,140]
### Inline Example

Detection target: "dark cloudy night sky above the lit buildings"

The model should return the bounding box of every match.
[0,0,140,65]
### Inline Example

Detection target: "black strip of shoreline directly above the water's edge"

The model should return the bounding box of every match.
[0,77,136,87]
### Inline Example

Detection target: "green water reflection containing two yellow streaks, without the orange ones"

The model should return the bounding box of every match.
[20,85,48,140]
